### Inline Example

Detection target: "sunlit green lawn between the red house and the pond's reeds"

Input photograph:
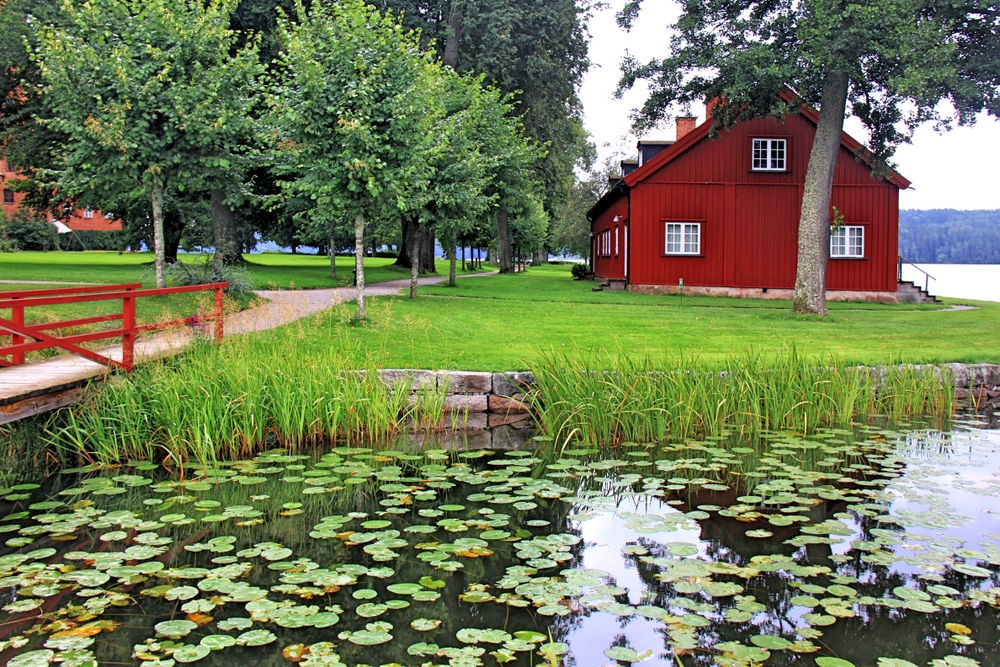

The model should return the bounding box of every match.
[259,265,1000,370]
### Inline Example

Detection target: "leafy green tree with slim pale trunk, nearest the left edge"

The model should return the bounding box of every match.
[36,0,260,287]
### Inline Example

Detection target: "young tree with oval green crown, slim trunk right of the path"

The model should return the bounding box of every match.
[271,0,440,319]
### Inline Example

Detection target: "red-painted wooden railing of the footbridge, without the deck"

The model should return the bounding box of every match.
[0,283,229,370]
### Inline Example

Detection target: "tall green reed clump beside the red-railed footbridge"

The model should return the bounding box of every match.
[51,336,440,464]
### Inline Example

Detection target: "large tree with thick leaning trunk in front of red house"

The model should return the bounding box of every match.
[619,0,1000,314]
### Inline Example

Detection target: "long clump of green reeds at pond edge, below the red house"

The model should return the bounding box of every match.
[531,350,955,445]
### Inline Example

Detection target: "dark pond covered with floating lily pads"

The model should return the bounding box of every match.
[0,422,1000,667]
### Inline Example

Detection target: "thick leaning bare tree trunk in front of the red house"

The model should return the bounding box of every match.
[792,72,849,315]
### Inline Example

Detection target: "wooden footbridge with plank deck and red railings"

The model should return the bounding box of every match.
[0,283,228,424]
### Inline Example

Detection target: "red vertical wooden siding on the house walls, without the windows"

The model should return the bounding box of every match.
[620,111,905,292]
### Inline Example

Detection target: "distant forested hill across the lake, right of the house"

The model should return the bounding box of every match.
[899,209,1000,264]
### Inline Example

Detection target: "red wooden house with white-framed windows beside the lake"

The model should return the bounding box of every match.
[587,99,910,302]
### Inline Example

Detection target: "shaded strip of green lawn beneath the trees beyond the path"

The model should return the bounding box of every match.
[0,251,486,290]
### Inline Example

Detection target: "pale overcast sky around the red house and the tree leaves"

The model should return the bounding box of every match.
[580,0,1000,209]
